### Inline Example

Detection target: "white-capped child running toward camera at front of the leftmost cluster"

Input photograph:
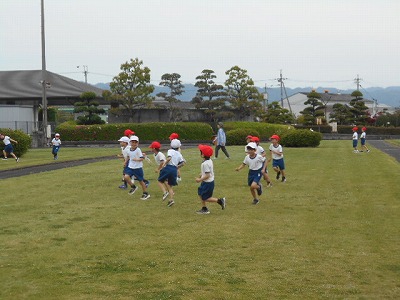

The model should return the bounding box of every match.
[125,135,150,200]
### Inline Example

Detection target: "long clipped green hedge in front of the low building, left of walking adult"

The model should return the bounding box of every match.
[56,122,213,141]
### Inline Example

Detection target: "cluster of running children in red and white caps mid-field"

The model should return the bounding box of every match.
[119,129,286,214]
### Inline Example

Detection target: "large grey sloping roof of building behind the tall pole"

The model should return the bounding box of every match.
[0,70,103,105]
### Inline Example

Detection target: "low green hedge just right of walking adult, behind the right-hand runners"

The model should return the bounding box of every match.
[224,122,293,143]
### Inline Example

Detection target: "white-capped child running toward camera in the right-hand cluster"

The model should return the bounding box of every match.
[236,142,265,205]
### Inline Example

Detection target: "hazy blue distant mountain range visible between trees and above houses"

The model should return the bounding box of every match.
[94,83,400,107]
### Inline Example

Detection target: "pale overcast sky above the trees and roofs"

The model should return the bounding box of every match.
[0,0,400,89]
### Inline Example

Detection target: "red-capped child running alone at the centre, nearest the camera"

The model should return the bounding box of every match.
[195,145,226,215]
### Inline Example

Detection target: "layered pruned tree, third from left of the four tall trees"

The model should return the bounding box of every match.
[192,69,232,122]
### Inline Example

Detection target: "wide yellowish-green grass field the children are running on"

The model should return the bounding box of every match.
[0,141,400,299]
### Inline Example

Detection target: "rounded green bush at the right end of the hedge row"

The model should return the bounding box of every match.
[280,129,322,147]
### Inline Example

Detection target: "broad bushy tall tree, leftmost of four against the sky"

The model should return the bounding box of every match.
[103,58,154,122]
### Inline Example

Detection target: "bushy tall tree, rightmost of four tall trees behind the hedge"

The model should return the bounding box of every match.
[225,66,263,120]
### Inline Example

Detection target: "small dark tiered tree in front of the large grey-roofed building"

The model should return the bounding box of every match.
[74,92,105,125]
